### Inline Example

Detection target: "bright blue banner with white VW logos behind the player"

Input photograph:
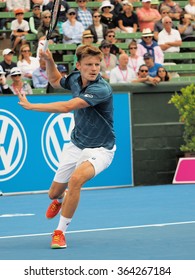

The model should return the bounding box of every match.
[0,93,133,193]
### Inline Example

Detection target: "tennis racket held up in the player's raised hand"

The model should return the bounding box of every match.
[43,0,61,52]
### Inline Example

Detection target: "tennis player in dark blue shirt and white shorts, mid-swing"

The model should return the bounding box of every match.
[19,45,116,249]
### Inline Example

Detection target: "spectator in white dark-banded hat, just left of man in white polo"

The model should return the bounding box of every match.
[137,28,164,63]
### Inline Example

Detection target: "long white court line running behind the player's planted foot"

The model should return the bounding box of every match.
[0,221,195,239]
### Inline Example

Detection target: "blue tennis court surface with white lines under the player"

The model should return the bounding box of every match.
[0,184,195,260]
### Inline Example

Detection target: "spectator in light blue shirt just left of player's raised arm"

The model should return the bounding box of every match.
[32,59,48,88]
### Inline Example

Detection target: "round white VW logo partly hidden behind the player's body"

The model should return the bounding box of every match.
[41,113,75,171]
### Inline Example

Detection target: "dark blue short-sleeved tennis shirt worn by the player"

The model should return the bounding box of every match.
[60,71,115,150]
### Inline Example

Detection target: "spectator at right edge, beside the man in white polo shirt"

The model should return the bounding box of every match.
[177,14,195,41]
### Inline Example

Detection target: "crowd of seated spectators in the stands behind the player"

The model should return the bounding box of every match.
[0,0,195,94]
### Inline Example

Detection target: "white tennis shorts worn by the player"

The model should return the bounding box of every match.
[54,142,116,183]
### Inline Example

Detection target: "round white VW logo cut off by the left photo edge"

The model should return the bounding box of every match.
[0,109,27,182]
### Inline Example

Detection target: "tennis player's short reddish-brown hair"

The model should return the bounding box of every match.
[76,45,103,61]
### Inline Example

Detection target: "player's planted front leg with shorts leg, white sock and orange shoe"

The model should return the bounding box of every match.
[51,147,115,248]
